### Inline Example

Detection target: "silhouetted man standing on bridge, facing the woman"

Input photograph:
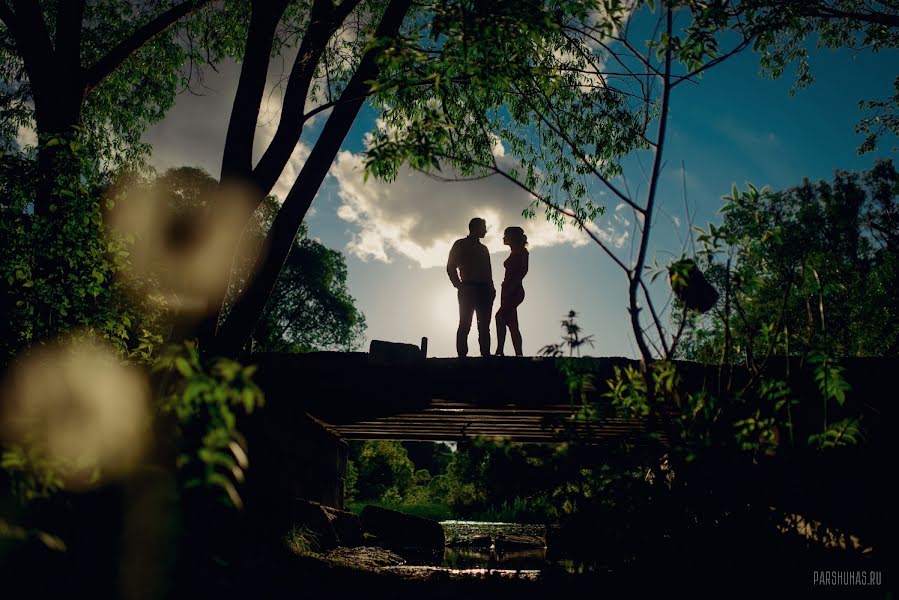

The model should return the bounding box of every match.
[446,217,496,356]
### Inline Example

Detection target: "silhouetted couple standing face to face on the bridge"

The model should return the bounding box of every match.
[446,217,528,356]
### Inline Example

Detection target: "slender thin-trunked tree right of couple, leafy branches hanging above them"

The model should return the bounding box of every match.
[367,3,751,361]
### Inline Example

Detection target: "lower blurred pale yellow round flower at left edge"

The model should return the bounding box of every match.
[0,335,150,490]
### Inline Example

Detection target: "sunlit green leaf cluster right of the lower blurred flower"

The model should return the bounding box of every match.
[153,343,264,507]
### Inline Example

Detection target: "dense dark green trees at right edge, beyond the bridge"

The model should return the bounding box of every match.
[682,161,899,370]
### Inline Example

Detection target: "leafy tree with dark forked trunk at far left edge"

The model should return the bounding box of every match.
[0,0,222,343]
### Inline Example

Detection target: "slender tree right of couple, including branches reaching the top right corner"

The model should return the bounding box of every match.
[367,0,899,361]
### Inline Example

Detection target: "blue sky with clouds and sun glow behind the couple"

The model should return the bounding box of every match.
[145,14,899,357]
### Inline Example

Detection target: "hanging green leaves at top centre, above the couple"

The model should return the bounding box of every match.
[366,2,647,227]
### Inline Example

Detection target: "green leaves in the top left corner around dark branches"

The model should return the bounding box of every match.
[0,0,225,170]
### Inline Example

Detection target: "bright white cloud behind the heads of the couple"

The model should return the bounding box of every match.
[331,151,629,268]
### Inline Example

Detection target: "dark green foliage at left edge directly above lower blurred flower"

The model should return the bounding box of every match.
[0,137,162,365]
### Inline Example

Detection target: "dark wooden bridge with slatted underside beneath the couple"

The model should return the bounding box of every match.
[254,352,664,443]
